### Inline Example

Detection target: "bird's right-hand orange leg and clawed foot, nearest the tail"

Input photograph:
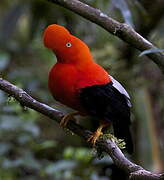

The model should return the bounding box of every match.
[87,123,107,147]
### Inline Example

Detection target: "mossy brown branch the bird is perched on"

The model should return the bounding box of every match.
[0,78,164,180]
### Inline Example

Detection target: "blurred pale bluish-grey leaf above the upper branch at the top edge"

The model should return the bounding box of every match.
[112,0,134,27]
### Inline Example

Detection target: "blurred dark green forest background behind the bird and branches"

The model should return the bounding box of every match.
[0,0,164,180]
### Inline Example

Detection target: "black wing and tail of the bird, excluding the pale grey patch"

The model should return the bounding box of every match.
[79,82,132,152]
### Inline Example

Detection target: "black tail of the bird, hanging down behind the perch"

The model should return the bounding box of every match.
[113,119,133,154]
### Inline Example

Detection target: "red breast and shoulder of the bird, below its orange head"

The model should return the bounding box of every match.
[48,63,109,111]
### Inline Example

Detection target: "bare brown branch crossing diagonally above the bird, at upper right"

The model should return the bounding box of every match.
[48,0,164,73]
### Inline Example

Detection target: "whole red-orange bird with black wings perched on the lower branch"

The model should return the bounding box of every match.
[43,24,133,153]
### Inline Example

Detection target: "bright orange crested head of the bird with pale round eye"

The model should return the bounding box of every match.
[43,24,92,63]
